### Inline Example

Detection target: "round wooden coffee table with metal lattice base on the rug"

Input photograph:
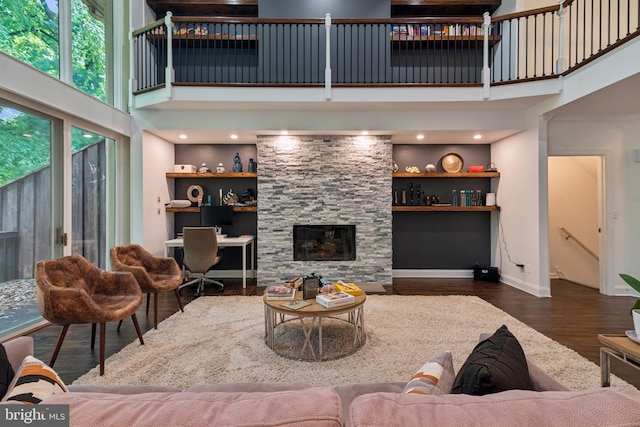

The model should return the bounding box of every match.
[262,292,367,361]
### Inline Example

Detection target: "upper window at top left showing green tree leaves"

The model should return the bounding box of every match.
[0,0,112,101]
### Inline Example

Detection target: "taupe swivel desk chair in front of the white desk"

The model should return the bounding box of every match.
[180,227,224,298]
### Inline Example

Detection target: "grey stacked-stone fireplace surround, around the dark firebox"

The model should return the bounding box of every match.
[257,135,392,286]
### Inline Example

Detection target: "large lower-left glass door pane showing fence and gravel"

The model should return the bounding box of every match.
[0,104,53,334]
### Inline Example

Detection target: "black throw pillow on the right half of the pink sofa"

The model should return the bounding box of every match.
[451,325,533,396]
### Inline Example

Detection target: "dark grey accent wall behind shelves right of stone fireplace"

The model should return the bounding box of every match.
[392,144,492,270]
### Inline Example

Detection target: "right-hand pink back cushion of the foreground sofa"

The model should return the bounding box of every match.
[349,387,640,427]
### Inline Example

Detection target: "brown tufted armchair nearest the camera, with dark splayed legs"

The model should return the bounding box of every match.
[35,255,144,375]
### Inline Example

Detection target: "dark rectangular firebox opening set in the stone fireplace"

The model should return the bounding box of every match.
[293,225,356,261]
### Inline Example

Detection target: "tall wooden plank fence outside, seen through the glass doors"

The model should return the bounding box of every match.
[0,141,106,283]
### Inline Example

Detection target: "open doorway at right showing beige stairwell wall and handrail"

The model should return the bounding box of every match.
[548,156,603,290]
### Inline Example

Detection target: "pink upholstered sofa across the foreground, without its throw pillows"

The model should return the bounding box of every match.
[5,337,640,427]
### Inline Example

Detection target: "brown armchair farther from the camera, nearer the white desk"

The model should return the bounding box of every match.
[111,244,184,329]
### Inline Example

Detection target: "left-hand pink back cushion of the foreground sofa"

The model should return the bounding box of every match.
[43,387,344,427]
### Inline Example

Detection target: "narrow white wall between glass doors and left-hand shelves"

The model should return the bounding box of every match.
[140,132,175,255]
